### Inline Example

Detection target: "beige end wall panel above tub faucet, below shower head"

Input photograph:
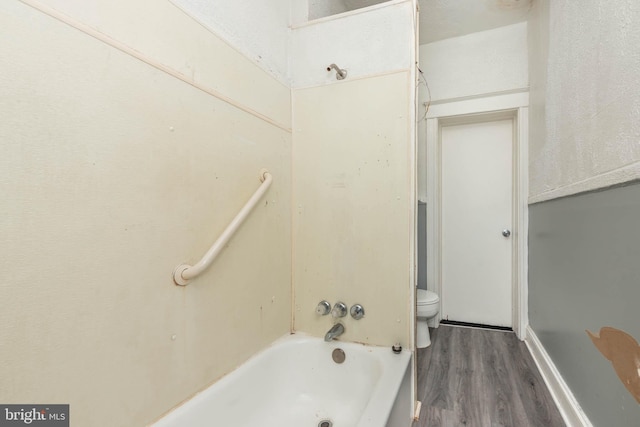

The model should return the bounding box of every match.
[293,71,415,346]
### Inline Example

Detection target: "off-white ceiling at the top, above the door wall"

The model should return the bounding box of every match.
[325,0,532,44]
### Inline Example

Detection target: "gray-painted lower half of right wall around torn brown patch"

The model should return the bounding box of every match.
[529,184,640,427]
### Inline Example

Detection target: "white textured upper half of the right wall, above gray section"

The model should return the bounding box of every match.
[529,0,640,201]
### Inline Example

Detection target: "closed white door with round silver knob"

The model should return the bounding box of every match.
[441,119,514,327]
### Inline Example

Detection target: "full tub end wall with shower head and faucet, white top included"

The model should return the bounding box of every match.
[292,1,416,347]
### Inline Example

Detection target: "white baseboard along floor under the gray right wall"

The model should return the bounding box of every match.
[524,326,593,427]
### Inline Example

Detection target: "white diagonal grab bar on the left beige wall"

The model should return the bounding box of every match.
[173,169,273,286]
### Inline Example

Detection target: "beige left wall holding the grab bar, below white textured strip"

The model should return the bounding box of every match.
[0,1,291,427]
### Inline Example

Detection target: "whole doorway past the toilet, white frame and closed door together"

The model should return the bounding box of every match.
[426,98,528,339]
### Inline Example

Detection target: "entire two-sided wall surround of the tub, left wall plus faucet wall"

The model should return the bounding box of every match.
[0,0,416,427]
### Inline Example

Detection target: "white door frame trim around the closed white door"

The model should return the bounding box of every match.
[426,92,529,340]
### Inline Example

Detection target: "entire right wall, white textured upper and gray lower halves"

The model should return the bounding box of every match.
[529,0,640,427]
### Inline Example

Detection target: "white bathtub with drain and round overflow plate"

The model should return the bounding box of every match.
[153,334,411,427]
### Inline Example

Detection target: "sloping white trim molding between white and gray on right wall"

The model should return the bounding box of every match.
[529,161,640,205]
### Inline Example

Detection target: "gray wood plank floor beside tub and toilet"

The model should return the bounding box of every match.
[414,325,565,427]
